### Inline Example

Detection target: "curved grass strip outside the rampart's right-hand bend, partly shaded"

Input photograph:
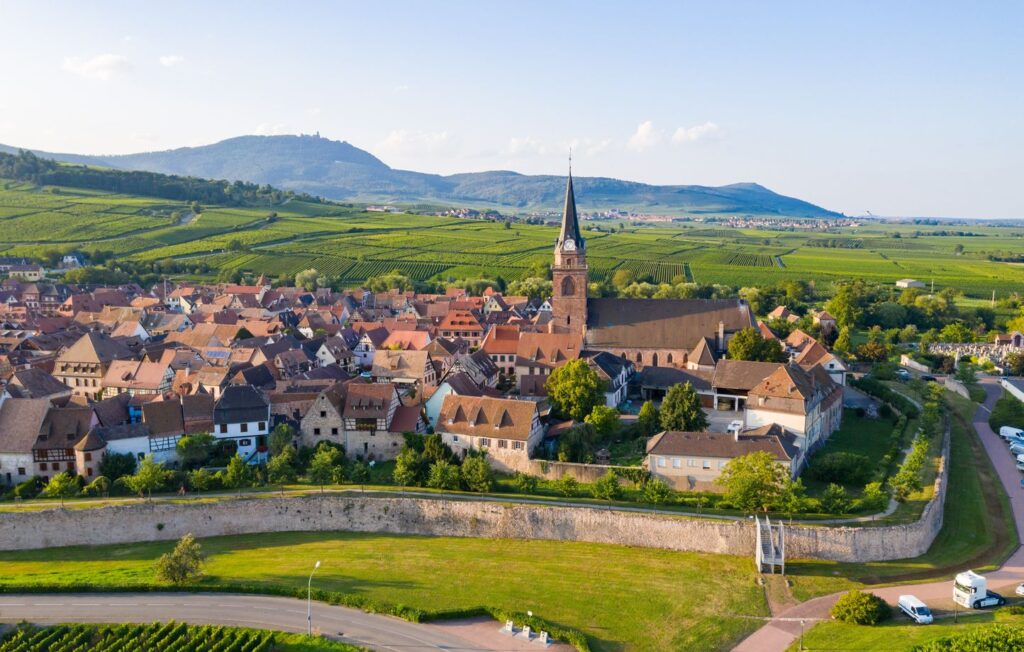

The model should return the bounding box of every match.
[785,392,1018,601]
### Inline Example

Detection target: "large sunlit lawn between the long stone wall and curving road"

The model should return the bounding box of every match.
[0,532,767,650]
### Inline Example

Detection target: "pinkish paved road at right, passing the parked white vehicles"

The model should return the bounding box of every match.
[733,378,1024,652]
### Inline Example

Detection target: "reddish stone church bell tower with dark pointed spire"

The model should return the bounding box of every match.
[551,169,587,334]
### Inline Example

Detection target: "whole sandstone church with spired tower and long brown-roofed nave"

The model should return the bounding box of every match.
[549,171,756,370]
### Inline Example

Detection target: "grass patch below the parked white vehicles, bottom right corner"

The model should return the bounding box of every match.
[790,611,1024,652]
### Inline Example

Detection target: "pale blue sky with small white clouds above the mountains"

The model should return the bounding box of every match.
[0,0,1024,218]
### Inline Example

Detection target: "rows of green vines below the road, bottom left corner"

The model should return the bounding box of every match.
[0,622,358,652]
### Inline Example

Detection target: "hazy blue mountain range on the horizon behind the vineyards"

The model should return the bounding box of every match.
[0,135,840,217]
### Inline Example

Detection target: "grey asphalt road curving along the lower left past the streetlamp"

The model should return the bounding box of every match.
[0,593,570,652]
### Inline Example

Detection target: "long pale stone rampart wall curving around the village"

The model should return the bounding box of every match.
[0,423,949,562]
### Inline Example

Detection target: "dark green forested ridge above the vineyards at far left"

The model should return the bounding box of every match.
[0,150,315,206]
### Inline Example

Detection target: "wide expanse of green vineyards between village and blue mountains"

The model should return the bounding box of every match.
[6,180,1024,299]
